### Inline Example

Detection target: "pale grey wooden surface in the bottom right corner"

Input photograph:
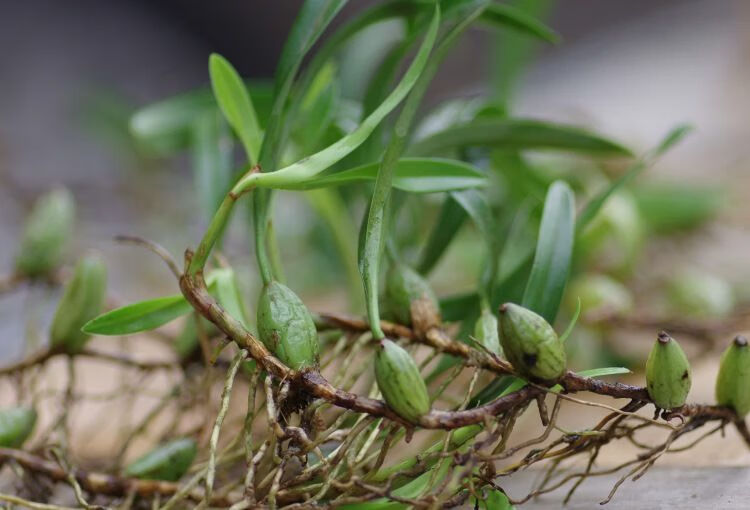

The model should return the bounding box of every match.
[500,467,750,510]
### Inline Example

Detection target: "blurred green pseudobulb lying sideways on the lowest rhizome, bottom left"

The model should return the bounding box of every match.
[125,438,198,482]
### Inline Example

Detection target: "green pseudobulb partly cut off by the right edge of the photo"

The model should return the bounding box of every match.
[716,336,750,417]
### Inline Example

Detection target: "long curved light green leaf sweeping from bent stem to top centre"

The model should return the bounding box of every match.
[234,10,440,193]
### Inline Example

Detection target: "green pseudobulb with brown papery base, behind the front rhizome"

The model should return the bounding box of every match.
[385,263,440,331]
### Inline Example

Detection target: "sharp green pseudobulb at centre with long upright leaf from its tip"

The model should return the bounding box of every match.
[375,339,430,423]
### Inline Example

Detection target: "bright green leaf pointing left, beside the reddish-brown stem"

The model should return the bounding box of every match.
[82,295,193,335]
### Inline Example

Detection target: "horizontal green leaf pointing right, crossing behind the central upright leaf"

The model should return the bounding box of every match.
[284,158,487,193]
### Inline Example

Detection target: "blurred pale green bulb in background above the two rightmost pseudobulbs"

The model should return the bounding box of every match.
[667,270,735,319]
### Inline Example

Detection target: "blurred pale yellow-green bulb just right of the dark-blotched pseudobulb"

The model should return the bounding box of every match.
[568,274,633,316]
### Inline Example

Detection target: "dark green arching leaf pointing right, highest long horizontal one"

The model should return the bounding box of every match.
[409,118,631,156]
